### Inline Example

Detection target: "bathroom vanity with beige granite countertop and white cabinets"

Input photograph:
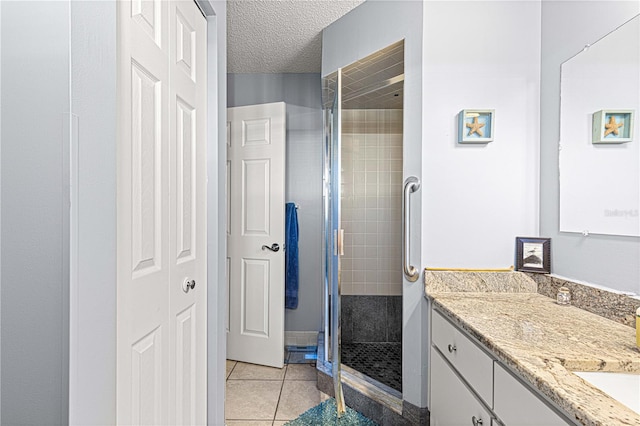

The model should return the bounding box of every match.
[425,272,640,426]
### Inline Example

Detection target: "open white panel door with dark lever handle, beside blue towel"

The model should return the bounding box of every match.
[227,102,286,368]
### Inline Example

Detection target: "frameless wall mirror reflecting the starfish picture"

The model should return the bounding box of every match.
[560,15,640,236]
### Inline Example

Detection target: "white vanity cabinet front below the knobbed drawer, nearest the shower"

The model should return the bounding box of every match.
[430,348,491,426]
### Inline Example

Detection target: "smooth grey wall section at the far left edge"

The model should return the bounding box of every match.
[0,2,69,425]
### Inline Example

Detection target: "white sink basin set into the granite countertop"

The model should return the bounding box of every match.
[574,371,640,414]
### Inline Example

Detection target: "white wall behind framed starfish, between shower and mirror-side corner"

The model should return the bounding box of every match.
[422,1,540,268]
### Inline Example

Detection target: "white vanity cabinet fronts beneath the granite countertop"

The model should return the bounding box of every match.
[429,310,573,426]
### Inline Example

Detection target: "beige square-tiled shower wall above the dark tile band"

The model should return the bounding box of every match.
[341,109,402,295]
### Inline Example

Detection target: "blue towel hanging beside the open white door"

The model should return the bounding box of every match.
[284,203,299,309]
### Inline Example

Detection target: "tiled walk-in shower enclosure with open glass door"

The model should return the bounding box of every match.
[321,41,404,398]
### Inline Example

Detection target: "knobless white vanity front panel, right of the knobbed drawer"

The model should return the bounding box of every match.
[493,363,570,426]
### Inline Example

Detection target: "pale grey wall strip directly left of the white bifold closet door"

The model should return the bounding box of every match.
[69,1,116,425]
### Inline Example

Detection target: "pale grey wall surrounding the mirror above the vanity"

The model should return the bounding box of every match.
[540,0,640,293]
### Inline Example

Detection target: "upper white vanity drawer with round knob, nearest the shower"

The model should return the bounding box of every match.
[431,310,493,407]
